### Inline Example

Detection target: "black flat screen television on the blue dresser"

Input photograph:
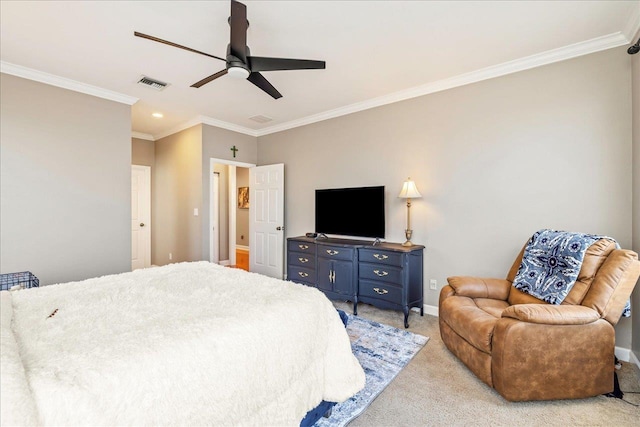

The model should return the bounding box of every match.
[315,186,385,239]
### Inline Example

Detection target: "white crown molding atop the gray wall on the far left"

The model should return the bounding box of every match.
[0,61,138,105]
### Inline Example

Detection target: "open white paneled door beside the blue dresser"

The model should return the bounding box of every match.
[249,163,284,279]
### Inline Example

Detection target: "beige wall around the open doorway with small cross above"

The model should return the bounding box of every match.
[202,125,258,260]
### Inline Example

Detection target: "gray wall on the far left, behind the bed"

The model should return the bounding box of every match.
[0,74,131,284]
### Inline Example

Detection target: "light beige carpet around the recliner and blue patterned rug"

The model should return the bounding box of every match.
[334,301,640,427]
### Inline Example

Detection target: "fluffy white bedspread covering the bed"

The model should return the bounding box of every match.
[0,262,364,426]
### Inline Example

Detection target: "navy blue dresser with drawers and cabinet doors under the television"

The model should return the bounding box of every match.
[287,236,424,328]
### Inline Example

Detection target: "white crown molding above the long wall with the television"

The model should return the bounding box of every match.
[252,32,629,136]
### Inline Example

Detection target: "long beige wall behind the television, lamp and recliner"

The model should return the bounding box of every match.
[258,48,640,348]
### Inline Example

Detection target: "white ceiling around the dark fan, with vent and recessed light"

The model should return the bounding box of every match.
[0,0,640,138]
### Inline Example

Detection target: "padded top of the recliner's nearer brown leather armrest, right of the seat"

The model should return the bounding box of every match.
[502,304,600,325]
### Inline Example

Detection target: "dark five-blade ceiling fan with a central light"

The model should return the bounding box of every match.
[133,0,325,99]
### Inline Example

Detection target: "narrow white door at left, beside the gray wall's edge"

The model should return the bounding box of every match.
[131,165,151,270]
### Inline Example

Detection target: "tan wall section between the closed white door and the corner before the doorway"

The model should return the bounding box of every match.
[151,125,204,265]
